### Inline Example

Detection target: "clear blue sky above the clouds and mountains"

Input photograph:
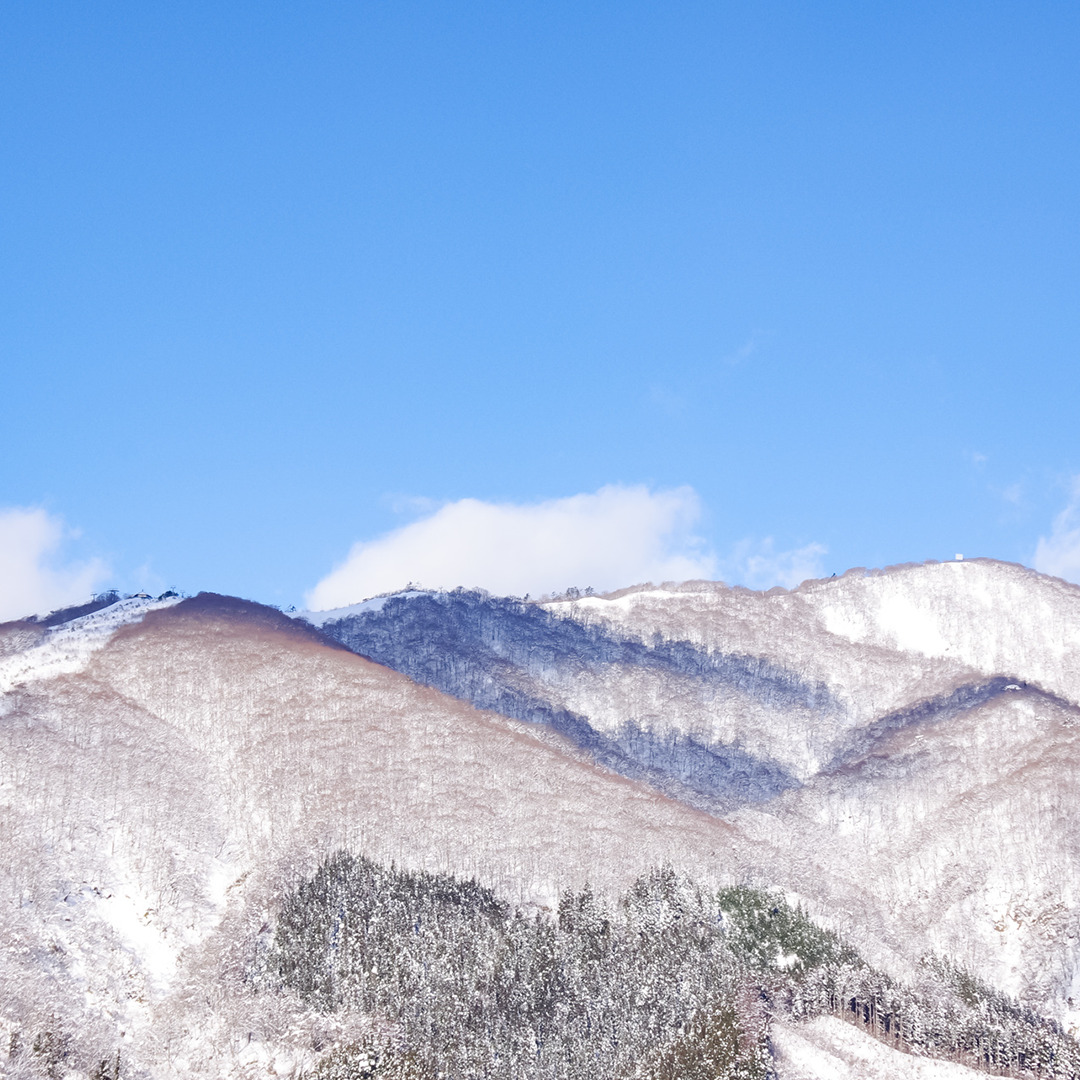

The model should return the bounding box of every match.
[0,0,1080,604]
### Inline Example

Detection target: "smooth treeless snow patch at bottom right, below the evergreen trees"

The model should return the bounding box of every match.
[771,1016,986,1080]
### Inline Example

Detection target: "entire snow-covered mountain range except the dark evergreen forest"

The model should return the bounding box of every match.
[0,561,1080,1080]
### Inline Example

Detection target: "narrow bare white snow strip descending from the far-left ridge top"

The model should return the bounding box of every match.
[0,596,180,693]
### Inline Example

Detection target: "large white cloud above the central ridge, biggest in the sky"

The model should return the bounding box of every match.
[307,486,715,610]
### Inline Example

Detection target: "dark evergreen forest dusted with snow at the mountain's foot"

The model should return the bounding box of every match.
[259,852,1080,1080]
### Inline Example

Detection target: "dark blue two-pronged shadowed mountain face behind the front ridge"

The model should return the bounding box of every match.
[308,590,820,810]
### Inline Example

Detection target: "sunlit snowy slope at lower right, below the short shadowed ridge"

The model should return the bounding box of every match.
[729,691,1080,1027]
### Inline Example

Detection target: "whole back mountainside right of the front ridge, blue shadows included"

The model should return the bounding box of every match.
[308,559,1080,1025]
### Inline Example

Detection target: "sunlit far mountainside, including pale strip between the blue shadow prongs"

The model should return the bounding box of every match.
[543,559,1080,780]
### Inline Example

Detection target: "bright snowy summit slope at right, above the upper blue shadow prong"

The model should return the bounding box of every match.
[548,558,1080,714]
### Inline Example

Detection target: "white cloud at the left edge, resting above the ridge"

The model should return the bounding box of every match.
[0,507,106,621]
